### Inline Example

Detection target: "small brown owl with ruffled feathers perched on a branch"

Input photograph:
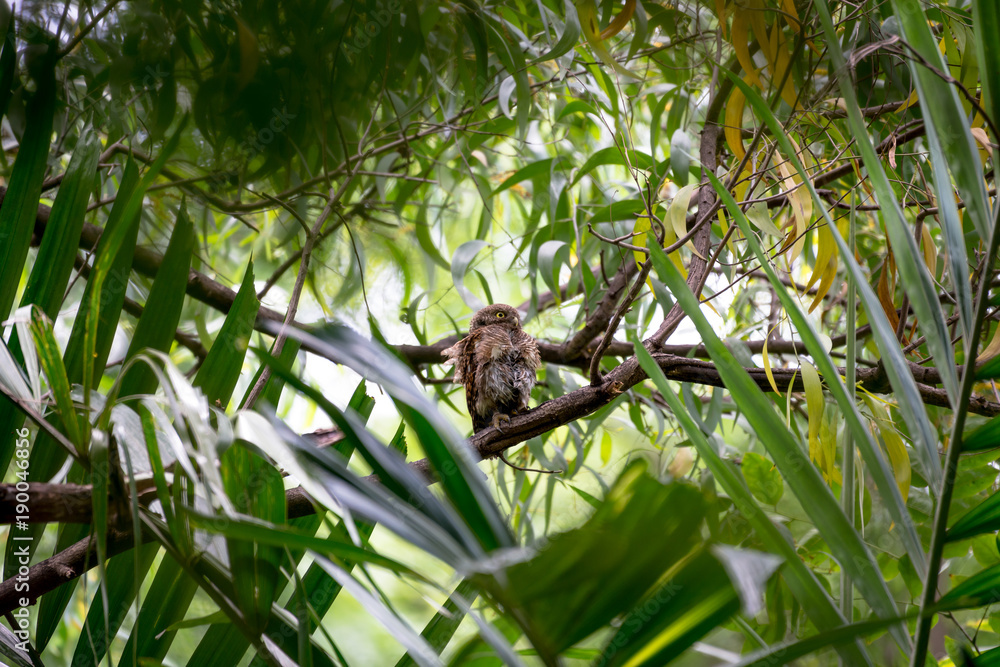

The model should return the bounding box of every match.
[442,303,542,433]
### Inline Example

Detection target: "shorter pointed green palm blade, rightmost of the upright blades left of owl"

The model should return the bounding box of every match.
[194,261,260,410]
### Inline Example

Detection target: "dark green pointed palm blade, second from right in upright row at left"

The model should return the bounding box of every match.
[118,203,195,397]
